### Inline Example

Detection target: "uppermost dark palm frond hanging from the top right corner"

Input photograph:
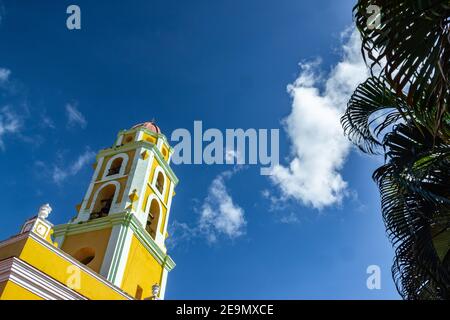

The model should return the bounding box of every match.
[354,0,450,139]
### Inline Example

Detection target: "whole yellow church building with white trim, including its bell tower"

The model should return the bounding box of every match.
[0,122,178,300]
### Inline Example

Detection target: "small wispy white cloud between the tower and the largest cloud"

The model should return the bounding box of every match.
[199,170,246,242]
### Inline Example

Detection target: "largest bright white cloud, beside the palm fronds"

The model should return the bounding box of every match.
[271,30,368,209]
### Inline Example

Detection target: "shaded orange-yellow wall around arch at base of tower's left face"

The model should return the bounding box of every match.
[61,228,111,273]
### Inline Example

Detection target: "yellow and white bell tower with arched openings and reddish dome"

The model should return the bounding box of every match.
[54,121,178,299]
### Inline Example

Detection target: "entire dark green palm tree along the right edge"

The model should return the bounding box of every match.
[341,0,450,299]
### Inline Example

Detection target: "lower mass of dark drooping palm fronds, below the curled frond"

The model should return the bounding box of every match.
[373,124,450,299]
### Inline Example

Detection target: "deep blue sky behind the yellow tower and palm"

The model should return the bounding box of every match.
[0,0,399,299]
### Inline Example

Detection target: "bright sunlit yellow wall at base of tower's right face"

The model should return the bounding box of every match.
[121,235,162,298]
